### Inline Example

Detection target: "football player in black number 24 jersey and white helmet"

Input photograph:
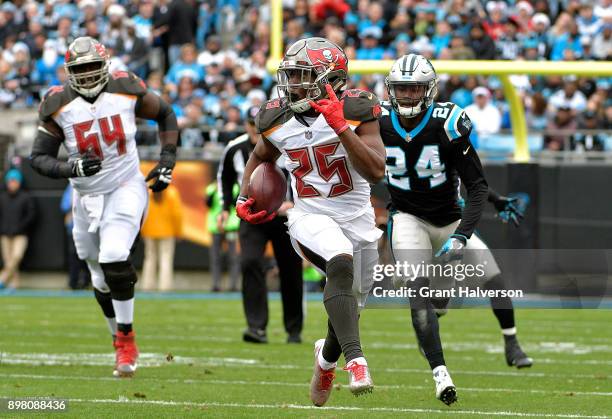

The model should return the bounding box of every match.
[380,54,531,404]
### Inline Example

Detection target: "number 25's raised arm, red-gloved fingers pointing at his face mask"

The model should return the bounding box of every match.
[310,84,385,183]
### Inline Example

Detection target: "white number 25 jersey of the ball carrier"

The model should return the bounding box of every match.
[255,90,381,222]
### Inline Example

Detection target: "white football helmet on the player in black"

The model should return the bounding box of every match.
[385,54,438,118]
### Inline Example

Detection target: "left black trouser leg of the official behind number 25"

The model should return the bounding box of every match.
[239,221,268,343]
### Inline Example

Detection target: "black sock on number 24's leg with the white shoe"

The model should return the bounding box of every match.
[410,278,446,370]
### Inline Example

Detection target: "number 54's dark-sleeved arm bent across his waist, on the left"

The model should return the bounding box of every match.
[30,119,102,179]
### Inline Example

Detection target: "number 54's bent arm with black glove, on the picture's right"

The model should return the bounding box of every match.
[136,92,178,192]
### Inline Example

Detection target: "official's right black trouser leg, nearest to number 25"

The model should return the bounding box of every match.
[266,217,304,343]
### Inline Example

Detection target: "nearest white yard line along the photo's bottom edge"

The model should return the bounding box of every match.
[58,399,609,419]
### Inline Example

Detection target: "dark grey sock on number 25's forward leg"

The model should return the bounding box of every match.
[323,255,363,363]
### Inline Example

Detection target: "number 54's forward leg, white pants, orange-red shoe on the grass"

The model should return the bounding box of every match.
[98,179,147,377]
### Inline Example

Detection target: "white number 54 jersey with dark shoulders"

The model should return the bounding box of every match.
[39,72,147,195]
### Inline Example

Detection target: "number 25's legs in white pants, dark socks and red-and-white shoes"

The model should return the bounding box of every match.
[289,214,373,406]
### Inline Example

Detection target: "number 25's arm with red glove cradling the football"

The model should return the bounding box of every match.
[236,135,280,224]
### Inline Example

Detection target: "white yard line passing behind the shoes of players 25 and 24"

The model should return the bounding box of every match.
[0,373,612,397]
